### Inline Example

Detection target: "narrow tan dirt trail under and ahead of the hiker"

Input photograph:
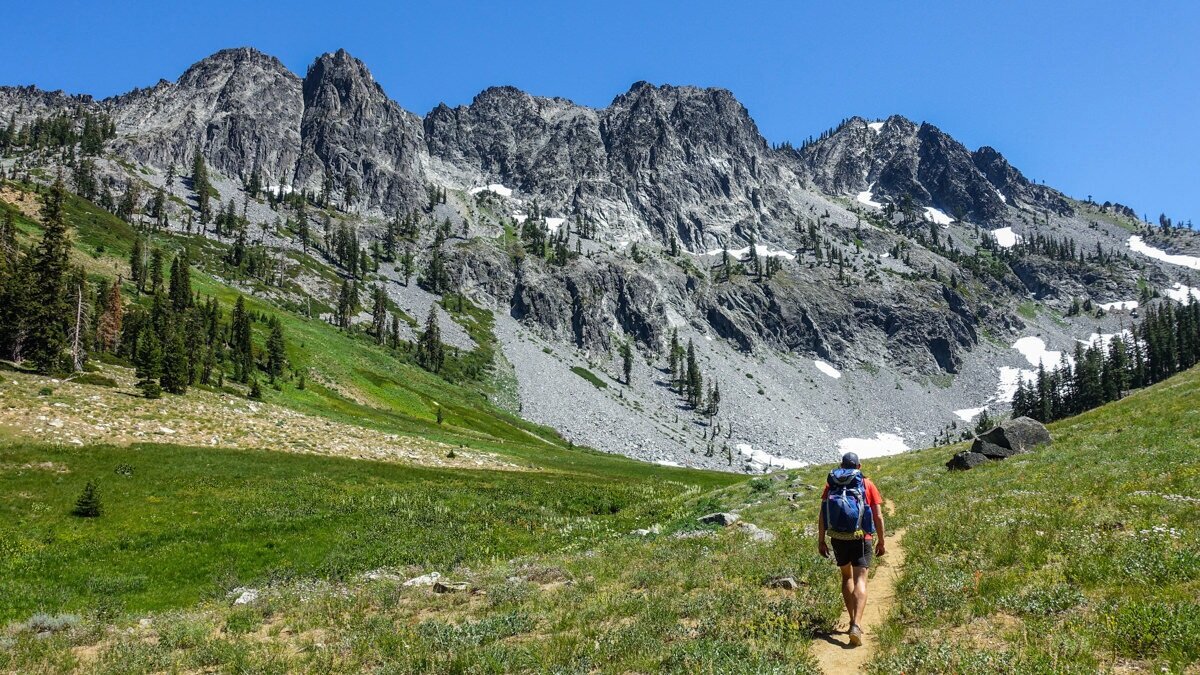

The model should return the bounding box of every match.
[812,502,904,675]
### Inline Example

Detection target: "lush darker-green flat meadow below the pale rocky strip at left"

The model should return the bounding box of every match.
[0,444,729,620]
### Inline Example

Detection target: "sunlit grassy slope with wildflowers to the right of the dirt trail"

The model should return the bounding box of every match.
[875,370,1200,673]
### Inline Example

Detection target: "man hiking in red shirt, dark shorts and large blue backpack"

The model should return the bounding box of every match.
[817,453,886,647]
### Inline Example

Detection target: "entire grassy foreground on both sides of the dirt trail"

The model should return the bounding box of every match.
[0,360,1200,673]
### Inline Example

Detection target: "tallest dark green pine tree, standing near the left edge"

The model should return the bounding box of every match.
[29,178,74,374]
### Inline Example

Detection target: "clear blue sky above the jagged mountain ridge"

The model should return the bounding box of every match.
[0,0,1200,221]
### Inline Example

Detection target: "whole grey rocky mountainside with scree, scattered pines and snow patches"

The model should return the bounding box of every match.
[7,48,1200,472]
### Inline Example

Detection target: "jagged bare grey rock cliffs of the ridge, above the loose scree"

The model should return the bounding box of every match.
[0,48,1161,372]
